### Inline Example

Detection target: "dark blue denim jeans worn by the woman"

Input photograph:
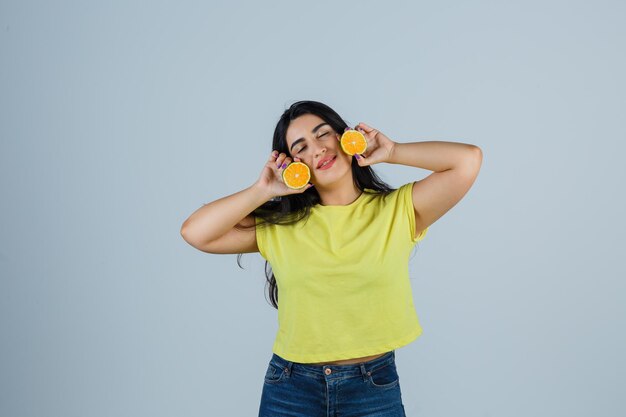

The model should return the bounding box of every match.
[259,350,406,417]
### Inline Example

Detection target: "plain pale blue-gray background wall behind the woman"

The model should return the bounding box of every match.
[0,1,626,417]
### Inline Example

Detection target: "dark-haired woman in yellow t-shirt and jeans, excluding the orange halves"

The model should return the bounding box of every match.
[181,101,482,417]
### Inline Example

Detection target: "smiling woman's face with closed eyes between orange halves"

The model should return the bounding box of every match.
[287,114,352,185]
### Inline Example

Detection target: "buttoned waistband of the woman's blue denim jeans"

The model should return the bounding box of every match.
[270,350,396,378]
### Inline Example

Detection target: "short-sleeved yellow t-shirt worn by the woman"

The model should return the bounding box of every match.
[256,182,428,362]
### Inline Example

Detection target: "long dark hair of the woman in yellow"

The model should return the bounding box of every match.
[235,100,395,309]
